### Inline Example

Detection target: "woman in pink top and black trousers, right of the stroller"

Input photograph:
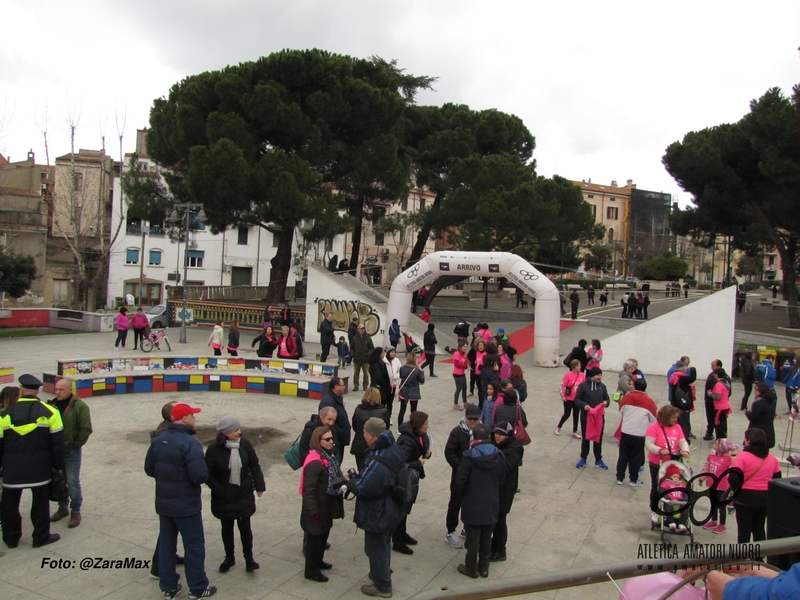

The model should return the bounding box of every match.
[728,429,781,544]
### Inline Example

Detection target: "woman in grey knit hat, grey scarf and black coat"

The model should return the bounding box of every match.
[206,416,267,573]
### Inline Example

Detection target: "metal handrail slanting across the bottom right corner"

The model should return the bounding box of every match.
[410,536,800,600]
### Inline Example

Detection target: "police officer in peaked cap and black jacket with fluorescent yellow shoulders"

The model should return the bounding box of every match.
[0,373,64,548]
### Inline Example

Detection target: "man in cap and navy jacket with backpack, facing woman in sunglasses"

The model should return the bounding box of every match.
[347,417,407,598]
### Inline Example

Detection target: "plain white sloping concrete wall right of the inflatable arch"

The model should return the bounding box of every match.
[600,287,736,376]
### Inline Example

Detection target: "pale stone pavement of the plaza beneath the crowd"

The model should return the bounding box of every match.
[0,314,786,600]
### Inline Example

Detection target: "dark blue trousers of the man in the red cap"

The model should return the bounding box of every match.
[158,513,208,592]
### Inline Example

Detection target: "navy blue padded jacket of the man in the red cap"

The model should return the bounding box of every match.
[144,423,208,517]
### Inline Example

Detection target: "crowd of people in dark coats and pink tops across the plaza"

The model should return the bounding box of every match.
[6,304,800,598]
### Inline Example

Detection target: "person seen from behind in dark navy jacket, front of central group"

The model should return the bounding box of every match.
[454,423,506,579]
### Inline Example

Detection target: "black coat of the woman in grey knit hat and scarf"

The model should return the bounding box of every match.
[206,438,267,519]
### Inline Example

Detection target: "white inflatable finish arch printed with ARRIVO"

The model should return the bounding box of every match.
[386,252,561,367]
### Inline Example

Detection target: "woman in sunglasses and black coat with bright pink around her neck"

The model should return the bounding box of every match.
[300,427,347,583]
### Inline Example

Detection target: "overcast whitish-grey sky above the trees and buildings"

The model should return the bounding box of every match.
[0,0,800,204]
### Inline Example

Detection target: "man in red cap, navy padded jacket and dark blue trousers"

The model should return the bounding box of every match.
[144,403,212,600]
